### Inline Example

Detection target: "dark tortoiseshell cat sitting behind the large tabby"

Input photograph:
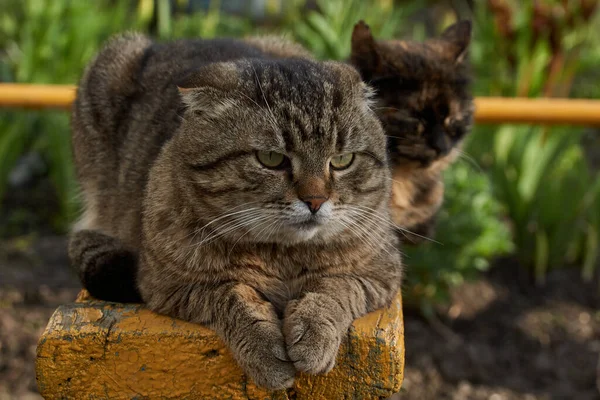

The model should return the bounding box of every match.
[351,21,474,243]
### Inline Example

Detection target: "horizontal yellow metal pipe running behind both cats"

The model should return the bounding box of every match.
[0,83,600,126]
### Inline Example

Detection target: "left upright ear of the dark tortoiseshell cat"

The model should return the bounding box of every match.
[350,20,381,80]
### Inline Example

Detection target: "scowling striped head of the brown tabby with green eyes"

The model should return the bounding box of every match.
[169,60,390,244]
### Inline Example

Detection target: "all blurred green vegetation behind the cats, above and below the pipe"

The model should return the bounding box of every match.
[0,0,600,313]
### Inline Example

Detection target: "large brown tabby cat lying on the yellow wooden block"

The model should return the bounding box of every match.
[69,35,402,389]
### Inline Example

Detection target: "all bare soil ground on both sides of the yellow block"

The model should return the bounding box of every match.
[0,236,600,400]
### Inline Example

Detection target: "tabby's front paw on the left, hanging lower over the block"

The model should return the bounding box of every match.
[238,321,296,390]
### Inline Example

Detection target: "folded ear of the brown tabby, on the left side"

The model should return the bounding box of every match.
[177,62,240,110]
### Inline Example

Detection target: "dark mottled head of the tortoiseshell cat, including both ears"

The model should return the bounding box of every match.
[351,21,473,167]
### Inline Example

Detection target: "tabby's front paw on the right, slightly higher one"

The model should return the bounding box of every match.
[283,295,341,374]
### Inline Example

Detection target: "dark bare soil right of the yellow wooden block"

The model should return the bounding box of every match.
[402,261,600,400]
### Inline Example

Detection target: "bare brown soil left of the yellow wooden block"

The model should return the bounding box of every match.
[0,236,79,400]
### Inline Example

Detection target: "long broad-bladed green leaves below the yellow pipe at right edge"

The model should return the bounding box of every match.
[474,125,600,283]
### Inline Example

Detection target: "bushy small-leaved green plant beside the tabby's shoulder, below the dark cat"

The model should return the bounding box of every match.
[404,160,514,316]
